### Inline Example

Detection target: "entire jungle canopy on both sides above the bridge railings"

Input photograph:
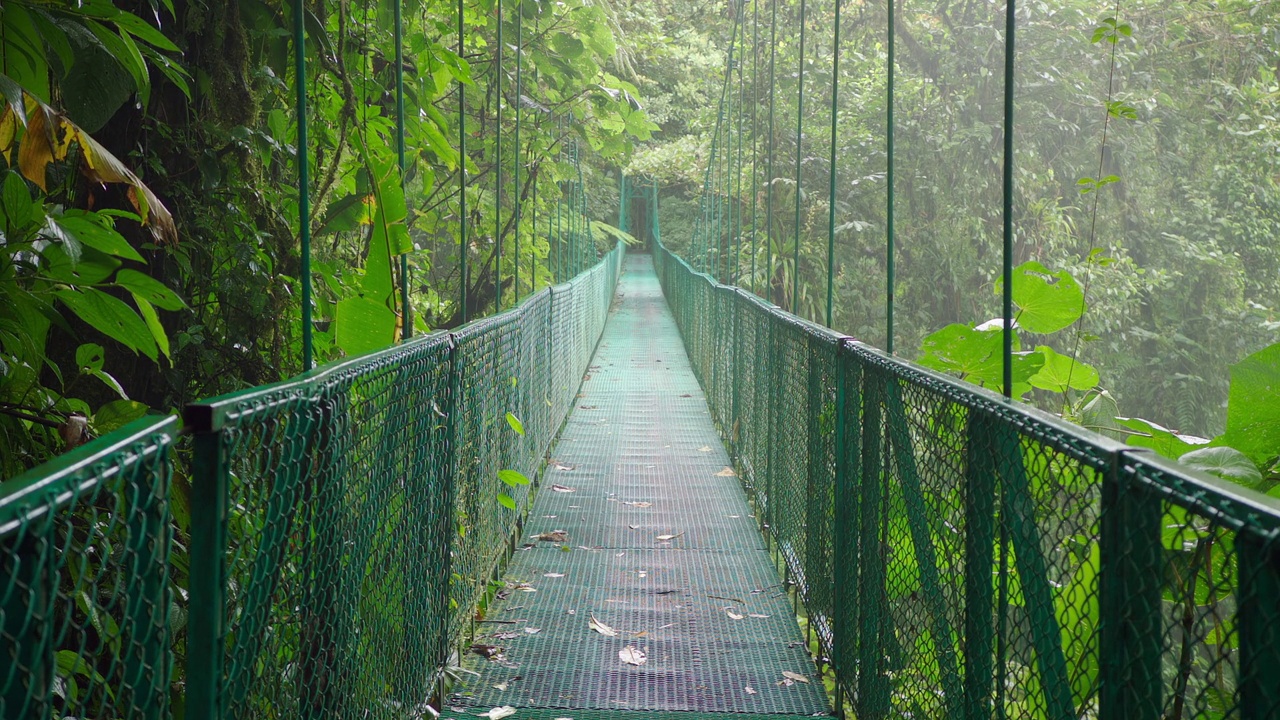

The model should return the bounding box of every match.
[0,0,1280,489]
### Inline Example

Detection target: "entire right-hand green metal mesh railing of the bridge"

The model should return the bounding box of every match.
[654,238,1280,719]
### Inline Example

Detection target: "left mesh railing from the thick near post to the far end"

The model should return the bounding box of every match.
[187,246,623,719]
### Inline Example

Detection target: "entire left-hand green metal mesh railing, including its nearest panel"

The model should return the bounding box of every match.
[0,245,625,720]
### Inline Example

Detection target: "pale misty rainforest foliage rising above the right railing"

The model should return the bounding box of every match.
[628,0,1280,481]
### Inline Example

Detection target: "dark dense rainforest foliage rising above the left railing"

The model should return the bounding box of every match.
[0,0,655,477]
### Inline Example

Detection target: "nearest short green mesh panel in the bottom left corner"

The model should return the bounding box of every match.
[0,418,179,719]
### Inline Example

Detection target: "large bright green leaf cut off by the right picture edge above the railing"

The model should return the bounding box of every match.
[1222,343,1280,464]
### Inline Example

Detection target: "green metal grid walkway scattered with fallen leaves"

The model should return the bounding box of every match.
[449,255,828,719]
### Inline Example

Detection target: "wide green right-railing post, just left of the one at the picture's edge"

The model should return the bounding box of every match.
[1087,452,1167,720]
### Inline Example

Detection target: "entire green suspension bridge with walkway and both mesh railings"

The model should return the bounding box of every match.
[0,4,1280,720]
